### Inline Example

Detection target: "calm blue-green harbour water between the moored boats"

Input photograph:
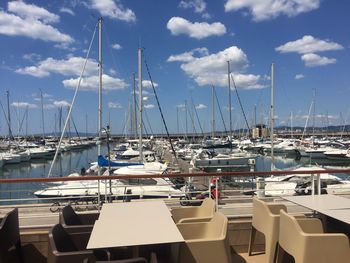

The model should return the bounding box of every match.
[0,146,350,202]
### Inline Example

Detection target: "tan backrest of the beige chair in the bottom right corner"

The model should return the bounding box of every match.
[278,210,303,255]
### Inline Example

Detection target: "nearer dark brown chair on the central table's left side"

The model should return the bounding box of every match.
[47,224,95,263]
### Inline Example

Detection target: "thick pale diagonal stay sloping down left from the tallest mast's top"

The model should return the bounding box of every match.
[47,20,101,177]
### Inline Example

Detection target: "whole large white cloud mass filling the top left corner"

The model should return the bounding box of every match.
[0,1,74,45]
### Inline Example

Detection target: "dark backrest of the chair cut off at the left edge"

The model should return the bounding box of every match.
[0,208,20,251]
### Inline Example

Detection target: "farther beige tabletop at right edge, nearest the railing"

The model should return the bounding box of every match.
[282,194,350,211]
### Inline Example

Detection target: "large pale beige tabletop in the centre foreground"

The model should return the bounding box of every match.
[87,201,184,249]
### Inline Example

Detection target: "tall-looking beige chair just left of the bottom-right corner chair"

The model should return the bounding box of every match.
[248,197,287,263]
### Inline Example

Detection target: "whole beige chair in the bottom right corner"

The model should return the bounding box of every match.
[277,211,350,263]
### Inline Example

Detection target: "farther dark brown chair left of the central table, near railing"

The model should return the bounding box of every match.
[59,205,99,232]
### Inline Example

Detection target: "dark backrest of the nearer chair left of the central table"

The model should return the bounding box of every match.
[49,224,78,252]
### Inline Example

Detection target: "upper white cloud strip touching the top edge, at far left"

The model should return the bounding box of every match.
[7,1,60,24]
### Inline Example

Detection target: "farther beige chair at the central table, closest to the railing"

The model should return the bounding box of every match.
[171,198,215,223]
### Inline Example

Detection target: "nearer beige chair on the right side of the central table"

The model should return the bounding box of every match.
[177,212,231,263]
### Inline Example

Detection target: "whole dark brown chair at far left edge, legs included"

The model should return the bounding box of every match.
[0,208,23,262]
